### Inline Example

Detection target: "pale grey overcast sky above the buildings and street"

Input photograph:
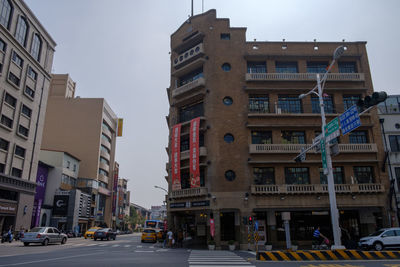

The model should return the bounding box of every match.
[26,0,400,208]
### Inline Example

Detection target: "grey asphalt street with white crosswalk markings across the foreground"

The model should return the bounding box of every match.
[0,234,400,267]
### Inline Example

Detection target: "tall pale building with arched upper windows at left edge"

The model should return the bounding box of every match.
[0,0,56,232]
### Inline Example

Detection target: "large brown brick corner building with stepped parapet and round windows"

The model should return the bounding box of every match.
[166,10,388,248]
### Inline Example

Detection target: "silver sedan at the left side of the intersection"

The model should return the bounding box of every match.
[21,227,68,246]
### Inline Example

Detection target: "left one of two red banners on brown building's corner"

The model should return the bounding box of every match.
[171,124,181,190]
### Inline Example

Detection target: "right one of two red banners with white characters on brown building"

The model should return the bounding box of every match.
[190,118,200,188]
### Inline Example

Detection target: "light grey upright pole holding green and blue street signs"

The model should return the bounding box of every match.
[317,74,344,249]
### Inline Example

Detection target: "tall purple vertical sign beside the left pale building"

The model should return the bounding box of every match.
[31,164,49,227]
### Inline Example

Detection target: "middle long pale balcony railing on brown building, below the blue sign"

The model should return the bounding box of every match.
[249,144,378,154]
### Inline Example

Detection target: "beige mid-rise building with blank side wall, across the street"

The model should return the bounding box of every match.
[42,74,117,226]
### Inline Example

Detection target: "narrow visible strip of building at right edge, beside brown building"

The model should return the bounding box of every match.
[378,95,400,225]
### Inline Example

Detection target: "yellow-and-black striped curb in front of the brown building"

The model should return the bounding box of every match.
[256,250,400,261]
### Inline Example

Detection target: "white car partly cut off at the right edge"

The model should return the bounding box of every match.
[358,228,400,251]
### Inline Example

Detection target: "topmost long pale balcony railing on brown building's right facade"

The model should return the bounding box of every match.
[246,73,365,82]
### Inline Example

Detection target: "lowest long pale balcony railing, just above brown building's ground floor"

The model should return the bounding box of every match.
[251,184,385,195]
